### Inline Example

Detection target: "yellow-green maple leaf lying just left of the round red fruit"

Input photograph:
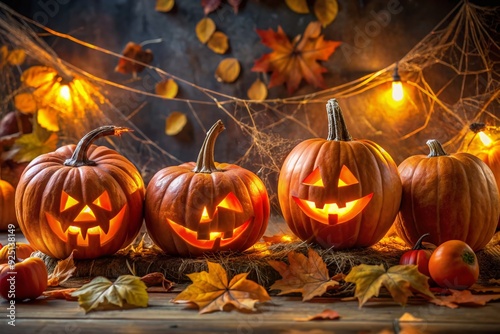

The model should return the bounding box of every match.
[345,264,434,308]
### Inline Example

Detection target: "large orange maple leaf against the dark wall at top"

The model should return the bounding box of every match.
[252,22,341,94]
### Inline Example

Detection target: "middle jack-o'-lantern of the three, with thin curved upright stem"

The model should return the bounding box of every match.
[145,121,270,256]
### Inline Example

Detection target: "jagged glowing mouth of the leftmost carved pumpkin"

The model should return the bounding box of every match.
[45,204,127,246]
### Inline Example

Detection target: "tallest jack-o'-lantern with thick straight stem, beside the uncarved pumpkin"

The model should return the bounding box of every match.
[278,99,401,249]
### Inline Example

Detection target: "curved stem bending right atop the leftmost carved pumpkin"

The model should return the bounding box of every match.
[64,125,132,167]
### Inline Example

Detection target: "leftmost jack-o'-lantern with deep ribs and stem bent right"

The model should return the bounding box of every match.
[16,126,145,259]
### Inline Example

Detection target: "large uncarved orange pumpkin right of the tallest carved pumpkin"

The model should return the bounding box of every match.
[395,140,499,251]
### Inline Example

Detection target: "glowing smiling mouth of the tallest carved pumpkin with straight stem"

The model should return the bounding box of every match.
[292,193,373,225]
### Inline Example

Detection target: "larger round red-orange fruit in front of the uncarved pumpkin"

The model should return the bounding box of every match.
[429,240,479,290]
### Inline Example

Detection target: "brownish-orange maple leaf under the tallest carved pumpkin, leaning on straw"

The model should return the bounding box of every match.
[268,248,339,301]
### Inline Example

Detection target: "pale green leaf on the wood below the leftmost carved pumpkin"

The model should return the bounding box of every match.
[71,275,149,313]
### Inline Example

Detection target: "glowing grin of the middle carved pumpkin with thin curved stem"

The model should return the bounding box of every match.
[167,218,253,250]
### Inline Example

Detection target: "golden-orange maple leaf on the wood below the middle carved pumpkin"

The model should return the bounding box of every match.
[173,261,271,313]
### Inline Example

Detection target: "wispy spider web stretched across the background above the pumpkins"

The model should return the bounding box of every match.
[0,1,500,209]
